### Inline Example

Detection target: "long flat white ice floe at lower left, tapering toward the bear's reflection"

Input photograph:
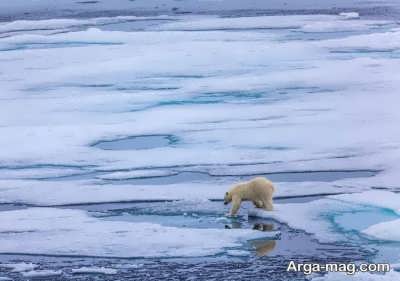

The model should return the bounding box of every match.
[0,208,276,258]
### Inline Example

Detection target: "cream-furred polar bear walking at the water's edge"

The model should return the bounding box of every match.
[224,177,275,216]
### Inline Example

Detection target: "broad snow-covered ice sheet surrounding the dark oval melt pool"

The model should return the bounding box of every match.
[0,16,398,179]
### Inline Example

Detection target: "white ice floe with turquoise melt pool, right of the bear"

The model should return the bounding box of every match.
[249,191,400,241]
